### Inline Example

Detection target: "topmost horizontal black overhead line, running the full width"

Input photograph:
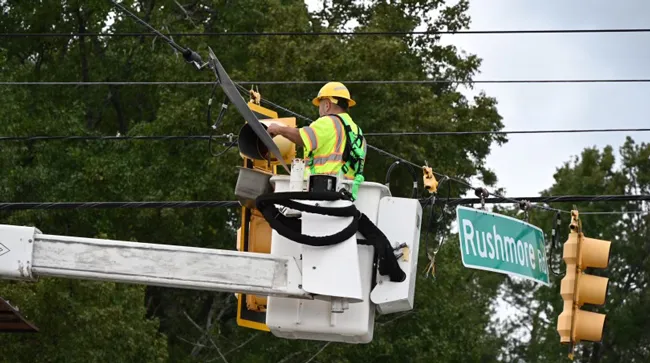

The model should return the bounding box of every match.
[0,28,650,38]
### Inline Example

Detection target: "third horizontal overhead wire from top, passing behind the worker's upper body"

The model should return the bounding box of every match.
[5,128,650,142]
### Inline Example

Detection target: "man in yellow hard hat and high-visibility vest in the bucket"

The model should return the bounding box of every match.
[267,82,367,199]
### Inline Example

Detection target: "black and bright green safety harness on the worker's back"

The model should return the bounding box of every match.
[307,114,366,201]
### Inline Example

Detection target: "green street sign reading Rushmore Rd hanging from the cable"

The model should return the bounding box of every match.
[456,206,550,286]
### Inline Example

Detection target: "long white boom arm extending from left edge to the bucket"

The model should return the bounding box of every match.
[0,225,311,299]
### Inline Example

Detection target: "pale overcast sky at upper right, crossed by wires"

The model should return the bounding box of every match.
[307,0,650,197]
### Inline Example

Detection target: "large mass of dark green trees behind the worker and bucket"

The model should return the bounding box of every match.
[0,0,506,362]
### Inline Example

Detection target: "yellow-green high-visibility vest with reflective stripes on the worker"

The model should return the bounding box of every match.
[300,113,367,185]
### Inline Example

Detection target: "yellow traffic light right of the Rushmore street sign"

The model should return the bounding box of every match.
[557,210,611,356]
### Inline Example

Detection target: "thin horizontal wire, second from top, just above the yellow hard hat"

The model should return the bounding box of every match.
[0,78,650,86]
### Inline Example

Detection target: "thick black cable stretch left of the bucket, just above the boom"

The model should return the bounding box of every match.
[0,201,239,211]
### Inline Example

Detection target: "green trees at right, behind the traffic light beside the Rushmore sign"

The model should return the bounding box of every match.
[498,138,650,363]
